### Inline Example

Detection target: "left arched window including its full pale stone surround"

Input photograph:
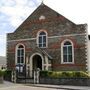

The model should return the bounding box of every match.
[15,43,25,64]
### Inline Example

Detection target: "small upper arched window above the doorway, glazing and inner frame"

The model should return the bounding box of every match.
[38,31,47,48]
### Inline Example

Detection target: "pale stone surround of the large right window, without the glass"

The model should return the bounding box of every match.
[61,39,74,64]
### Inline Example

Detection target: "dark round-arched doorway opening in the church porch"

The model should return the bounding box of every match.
[32,55,42,70]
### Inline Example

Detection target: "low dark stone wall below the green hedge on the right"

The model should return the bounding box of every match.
[40,78,90,86]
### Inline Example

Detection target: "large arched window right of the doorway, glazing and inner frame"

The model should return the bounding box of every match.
[61,40,74,63]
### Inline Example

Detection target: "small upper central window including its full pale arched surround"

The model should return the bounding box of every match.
[37,30,48,48]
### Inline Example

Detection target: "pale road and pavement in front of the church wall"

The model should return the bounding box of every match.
[0,81,90,90]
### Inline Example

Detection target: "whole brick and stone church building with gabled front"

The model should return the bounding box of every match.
[7,4,88,77]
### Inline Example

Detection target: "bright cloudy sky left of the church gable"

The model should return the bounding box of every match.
[0,0,41,56]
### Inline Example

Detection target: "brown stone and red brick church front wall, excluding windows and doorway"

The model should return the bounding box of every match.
[7,4,87,76]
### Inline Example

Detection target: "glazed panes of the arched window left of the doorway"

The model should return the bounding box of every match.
[16,45,25,64]
